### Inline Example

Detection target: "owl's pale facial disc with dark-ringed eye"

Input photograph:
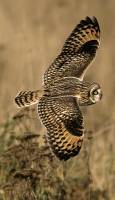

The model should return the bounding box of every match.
[90,84,102,103]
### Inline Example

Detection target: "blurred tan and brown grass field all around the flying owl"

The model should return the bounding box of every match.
[0,0,115,200]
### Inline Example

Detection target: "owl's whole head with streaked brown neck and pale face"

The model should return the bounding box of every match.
[79,82,102,106]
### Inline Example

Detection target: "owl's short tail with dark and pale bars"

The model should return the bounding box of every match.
[15,90,43,107]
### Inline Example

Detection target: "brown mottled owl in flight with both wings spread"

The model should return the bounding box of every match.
[15,17,102,160]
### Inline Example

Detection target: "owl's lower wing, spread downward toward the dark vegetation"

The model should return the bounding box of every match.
[38,97,84,160]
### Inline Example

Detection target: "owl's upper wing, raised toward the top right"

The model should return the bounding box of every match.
[44,17,100,86]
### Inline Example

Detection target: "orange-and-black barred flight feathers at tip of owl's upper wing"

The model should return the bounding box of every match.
[62,17,100,54]
